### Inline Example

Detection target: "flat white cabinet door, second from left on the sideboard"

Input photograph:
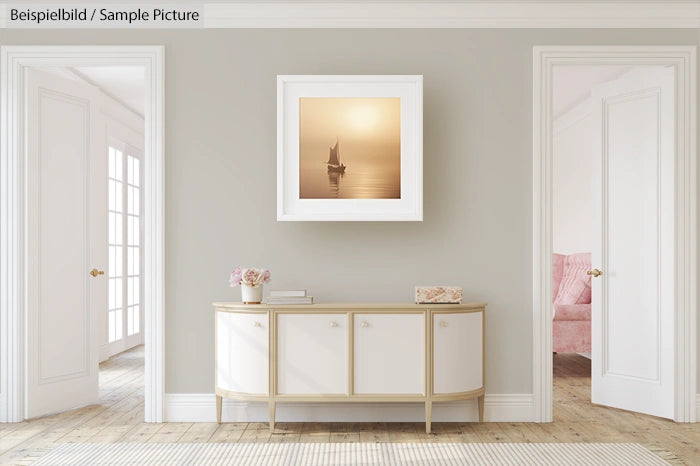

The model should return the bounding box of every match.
[277,314,347,395]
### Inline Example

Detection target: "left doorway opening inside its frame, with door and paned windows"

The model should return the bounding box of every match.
[25,66,145,418]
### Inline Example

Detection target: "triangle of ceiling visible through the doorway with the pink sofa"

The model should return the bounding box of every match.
[552,65,630,118]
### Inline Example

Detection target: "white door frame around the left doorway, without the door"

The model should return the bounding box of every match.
[0,45,165,422]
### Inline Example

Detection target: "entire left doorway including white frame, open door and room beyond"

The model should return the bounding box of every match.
[0,46,163,422]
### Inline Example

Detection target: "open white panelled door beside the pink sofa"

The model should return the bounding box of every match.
[591,67,675,418]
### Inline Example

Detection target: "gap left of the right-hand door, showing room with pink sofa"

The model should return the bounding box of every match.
[552,65,633,419]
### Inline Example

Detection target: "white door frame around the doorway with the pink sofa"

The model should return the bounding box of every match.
[532,45,698,422]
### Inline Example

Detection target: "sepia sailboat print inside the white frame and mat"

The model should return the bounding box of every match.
[299,97,401,199]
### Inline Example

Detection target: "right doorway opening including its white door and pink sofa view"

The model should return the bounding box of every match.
[552,65,675,419]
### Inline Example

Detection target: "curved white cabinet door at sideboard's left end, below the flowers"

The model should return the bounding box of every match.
[216,311,269,394]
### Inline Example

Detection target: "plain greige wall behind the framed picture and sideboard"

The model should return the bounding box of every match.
[0,29,700,393]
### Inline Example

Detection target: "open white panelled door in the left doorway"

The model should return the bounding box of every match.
[25,70,107,418]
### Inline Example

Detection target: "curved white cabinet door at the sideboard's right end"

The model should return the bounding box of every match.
[433,312,483,393]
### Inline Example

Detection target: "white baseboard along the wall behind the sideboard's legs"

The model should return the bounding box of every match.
[165,393,533,422]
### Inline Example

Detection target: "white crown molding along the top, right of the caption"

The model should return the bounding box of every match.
[203,0,700,28]
